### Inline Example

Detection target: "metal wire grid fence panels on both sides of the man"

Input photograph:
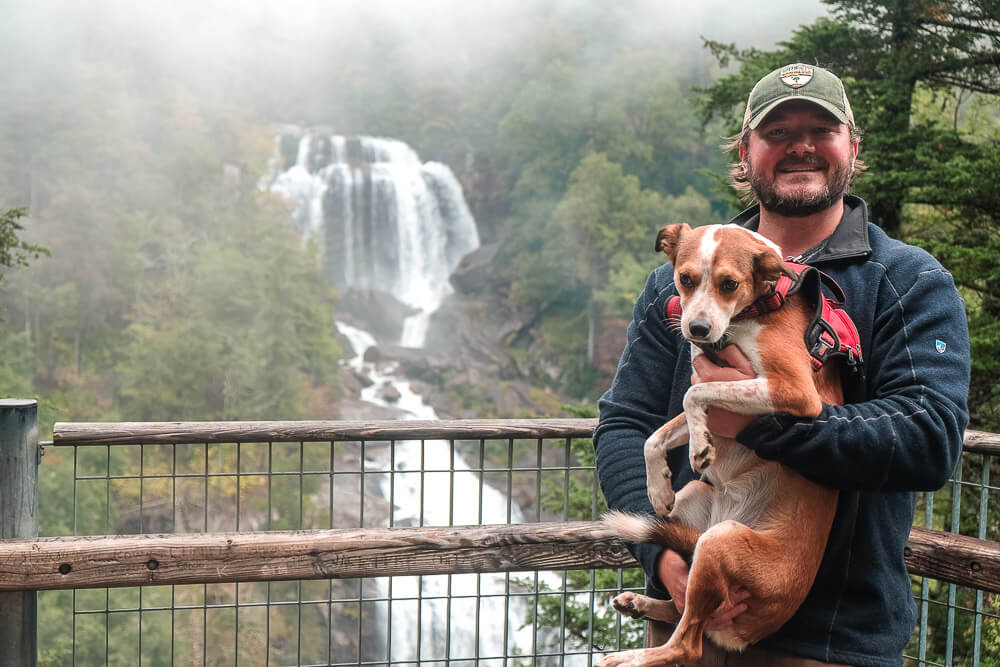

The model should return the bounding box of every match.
[39,440,1000,666]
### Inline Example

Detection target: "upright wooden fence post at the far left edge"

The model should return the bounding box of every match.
[0,398,39,667]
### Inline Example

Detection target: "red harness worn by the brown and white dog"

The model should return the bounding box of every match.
[665,261,863,373]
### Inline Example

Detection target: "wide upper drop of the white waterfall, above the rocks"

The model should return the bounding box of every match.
[270,133,479,347]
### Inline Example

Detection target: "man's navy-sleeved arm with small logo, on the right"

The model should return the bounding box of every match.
[737,269,970,491]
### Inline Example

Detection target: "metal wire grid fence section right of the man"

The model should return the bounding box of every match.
[904,452,1000,667]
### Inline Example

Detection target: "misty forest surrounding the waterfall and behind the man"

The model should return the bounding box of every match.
[0,0,1000,664]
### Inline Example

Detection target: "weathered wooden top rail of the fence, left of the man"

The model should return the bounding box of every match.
[52,419,597,446]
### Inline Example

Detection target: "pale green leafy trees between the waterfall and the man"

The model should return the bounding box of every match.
[512,153,713,396]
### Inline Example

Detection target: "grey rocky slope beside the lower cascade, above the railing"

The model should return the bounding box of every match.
[330,239,600,419]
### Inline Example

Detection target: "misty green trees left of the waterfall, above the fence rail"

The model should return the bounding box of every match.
[0,77,339,428]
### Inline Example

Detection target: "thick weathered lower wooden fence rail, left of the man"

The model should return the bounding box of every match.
[0,522,635,591]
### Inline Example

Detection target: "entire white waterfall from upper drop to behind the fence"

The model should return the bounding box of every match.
[264,133,533,661]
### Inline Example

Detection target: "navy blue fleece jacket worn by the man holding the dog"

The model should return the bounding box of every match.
[594,196,969,666]
